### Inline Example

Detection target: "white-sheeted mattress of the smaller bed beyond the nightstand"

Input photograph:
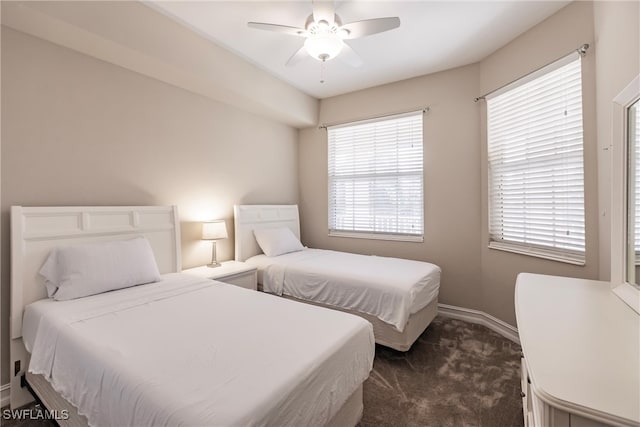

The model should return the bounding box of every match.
[245,248,441,332]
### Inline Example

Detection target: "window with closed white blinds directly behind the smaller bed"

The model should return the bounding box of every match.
[327,111,424,241]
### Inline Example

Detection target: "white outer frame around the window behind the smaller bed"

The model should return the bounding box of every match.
[326,110,426,242]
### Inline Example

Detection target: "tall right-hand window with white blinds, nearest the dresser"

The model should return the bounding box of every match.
[487,54,585,264]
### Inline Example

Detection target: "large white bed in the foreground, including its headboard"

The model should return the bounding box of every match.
[11,207,375,426]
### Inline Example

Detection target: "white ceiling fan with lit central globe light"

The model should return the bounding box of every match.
[247,1,400,67]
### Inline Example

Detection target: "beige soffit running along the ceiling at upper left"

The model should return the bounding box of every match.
[2,0,318,127]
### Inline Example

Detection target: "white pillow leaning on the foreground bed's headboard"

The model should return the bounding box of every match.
[40,237,160,301]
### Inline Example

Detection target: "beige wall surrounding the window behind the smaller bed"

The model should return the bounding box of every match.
[299,65,482,318]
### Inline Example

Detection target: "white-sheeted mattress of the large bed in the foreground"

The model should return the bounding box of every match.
[23,274,375,426]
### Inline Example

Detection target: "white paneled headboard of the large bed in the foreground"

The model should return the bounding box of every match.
[11,206,181,339]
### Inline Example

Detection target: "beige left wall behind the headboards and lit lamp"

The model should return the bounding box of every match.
[0,27,298,384]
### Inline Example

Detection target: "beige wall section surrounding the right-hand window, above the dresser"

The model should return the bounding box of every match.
[478,2,599,325]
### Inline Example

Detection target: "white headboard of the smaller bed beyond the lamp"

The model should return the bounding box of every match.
[233,205,300,261]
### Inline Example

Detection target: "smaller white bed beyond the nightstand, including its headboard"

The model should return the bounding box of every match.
[235,205,441,351]
